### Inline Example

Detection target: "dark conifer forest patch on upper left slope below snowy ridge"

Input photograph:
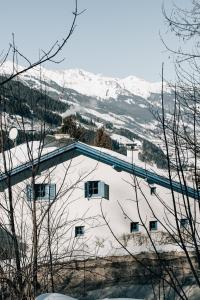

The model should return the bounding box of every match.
[0,76,69,126]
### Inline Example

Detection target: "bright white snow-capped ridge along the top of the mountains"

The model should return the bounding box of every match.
[0,61,167,99]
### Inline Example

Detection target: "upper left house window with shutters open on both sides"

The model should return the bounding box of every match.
[26,183,56,201]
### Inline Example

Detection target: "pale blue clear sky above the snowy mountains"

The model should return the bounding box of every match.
[0,0,189,81]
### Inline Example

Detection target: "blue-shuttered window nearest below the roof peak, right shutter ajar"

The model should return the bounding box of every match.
[85,181,109,200]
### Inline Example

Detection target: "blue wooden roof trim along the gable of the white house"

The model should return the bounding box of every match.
[0,142,199,199]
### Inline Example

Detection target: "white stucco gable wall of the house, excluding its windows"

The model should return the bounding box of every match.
[0,142,197,258]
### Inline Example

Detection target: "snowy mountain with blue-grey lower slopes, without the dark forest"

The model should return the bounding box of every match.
[0,62,173,142]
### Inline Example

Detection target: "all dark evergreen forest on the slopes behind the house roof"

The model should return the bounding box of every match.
[0,76,167,168]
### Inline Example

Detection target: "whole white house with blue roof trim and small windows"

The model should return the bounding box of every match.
[0,142,196,258]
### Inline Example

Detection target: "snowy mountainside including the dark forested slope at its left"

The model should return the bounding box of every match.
[0,62,174,148]
